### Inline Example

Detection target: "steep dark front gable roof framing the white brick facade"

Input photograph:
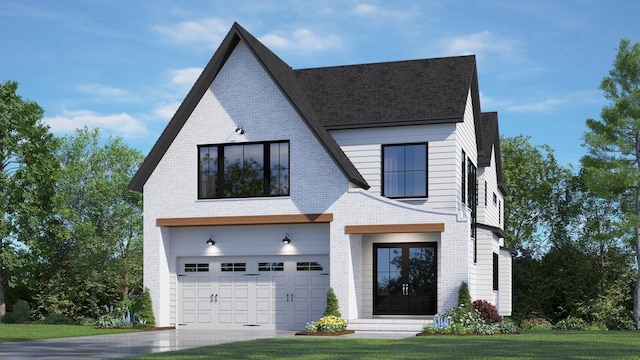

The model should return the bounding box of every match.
[129,23,369,192]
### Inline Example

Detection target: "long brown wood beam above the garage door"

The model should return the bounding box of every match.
[156,213,333,227]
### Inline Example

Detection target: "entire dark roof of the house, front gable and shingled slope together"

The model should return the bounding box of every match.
[129,23,501,191]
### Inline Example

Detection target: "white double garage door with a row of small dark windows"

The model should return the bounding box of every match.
[178,256,329,330]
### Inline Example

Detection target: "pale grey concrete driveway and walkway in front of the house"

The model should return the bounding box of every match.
[0,329,415,360]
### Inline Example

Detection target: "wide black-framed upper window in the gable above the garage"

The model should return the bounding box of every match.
[198,141,289,199]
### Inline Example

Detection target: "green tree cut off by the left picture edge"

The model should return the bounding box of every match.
[0,81,57,315]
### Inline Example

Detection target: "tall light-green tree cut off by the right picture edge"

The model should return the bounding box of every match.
[582,39,640,330]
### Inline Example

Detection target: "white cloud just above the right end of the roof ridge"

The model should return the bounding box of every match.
[442,30,515,56]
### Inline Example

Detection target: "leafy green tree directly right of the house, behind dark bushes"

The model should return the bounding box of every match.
[500,135,576,257]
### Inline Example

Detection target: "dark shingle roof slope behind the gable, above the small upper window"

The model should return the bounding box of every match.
[295,55,475,129]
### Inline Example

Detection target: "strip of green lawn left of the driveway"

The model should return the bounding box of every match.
[0,324,141,343]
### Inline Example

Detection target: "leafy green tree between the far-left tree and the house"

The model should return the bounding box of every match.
[34,128,143,317]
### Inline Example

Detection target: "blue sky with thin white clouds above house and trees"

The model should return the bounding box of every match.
[0,0,640,164]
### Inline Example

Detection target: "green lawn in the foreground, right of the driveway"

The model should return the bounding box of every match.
[130,331,640,360]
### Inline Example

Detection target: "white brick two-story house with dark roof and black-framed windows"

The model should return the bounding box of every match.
[130,24,511,331]
